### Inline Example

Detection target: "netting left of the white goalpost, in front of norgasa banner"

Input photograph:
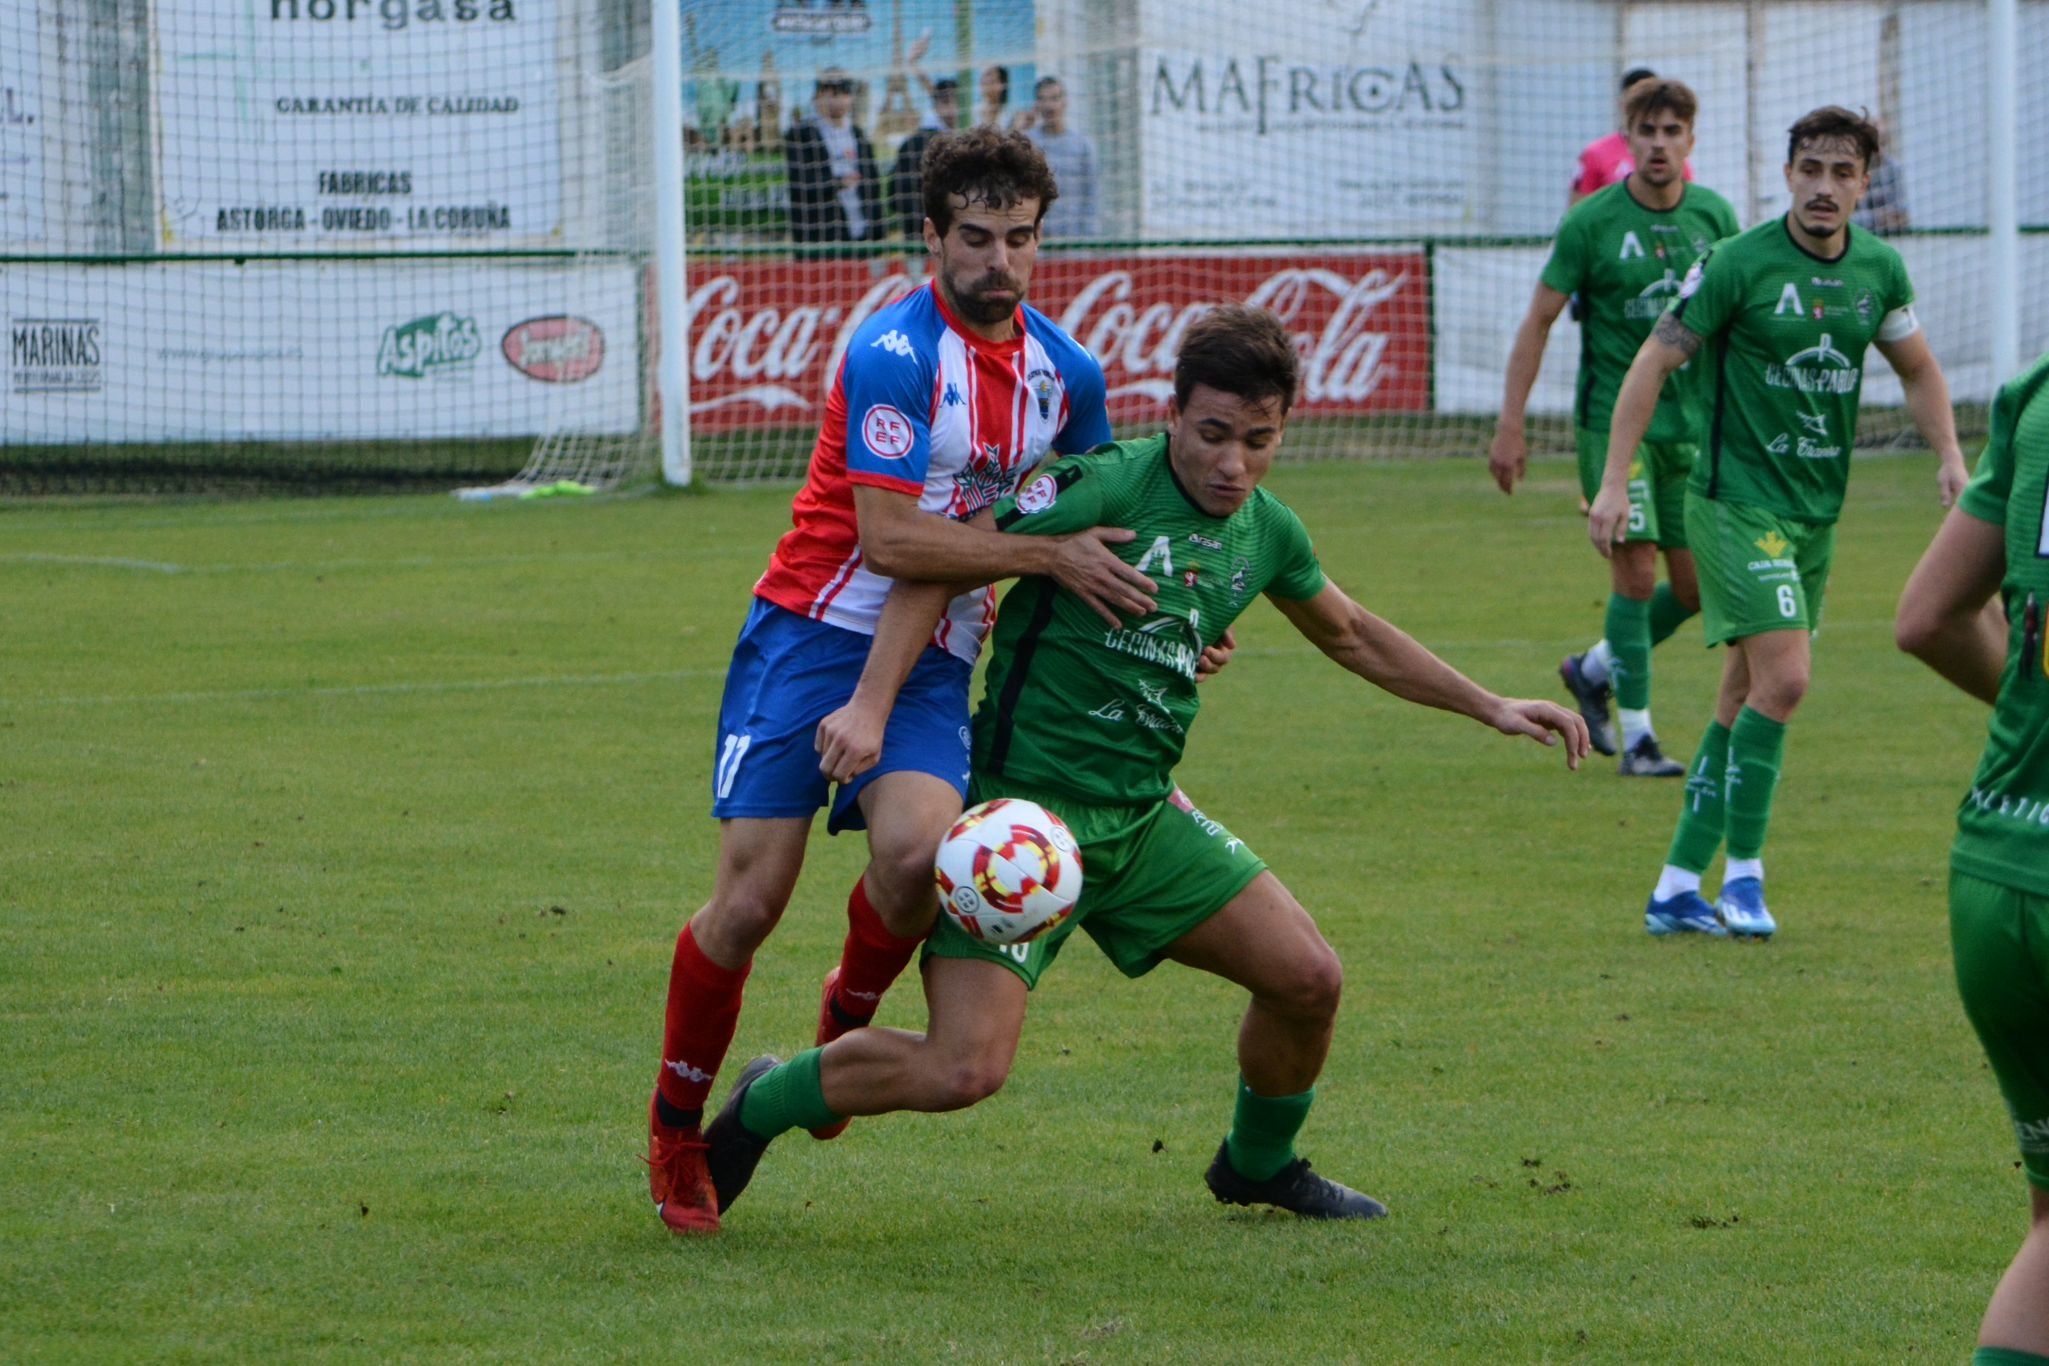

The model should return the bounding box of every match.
[0,0,654,489]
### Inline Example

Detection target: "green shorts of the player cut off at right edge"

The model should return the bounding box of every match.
[1949,868,2049,1190]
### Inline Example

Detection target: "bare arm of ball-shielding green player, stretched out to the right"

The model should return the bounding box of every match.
[1272,582,1590,768]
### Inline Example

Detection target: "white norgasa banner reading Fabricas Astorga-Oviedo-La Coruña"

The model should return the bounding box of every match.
[156,0,561,252]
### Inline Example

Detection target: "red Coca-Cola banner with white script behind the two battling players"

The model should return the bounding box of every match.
[688,248,1430,430]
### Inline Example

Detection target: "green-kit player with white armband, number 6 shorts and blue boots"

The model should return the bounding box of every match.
[1586,106,1965,938]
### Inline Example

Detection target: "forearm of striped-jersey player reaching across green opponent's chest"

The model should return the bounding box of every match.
[854,483,1154,627]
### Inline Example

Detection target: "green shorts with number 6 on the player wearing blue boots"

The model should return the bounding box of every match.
[1686,494,1836,645]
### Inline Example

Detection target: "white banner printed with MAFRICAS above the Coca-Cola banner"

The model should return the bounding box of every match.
[1135,0,1492,240]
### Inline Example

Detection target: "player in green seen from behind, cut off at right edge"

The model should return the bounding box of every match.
[1897,356,2049,1366]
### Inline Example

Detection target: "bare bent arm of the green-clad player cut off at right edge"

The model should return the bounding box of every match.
[1893,508,2006,702]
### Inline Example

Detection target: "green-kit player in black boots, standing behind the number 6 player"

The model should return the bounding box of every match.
[1488,76,1738,778]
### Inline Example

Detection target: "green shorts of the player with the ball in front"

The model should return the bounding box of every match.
[924,774,1266,987]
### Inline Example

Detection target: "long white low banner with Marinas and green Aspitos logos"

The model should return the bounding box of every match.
[0,262,641,444]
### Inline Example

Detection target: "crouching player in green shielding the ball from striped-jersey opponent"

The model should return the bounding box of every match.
[705,307,1588,1219]
